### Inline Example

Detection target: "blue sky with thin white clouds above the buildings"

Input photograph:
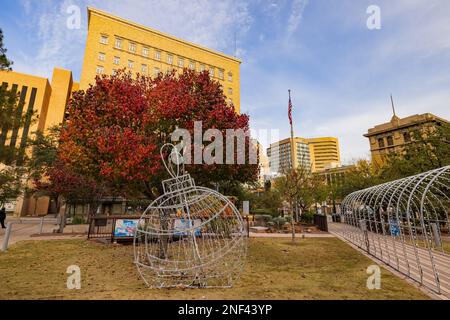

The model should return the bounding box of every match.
[0,0,450,163]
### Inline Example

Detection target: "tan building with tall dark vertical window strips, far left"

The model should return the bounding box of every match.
[0,68,78,215]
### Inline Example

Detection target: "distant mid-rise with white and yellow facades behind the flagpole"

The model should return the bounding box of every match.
[267,137,340,173]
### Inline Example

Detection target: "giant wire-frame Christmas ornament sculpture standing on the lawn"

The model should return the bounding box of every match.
[134,144,247,288]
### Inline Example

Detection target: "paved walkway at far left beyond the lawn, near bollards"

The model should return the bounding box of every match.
[0,217,87,247]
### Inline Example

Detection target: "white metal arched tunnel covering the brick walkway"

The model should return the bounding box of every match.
[330,166,450,298]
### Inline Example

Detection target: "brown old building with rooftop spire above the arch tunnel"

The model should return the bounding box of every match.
[364,113,449,165]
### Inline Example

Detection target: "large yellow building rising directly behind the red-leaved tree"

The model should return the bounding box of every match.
[80,8,241,112]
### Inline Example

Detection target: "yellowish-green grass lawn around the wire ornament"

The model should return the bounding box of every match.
[0,238,428,299]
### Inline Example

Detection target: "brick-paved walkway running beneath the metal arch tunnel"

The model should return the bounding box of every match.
[329,223,450,298]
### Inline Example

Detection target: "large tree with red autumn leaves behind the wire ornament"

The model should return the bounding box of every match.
[58,69,258,197]
